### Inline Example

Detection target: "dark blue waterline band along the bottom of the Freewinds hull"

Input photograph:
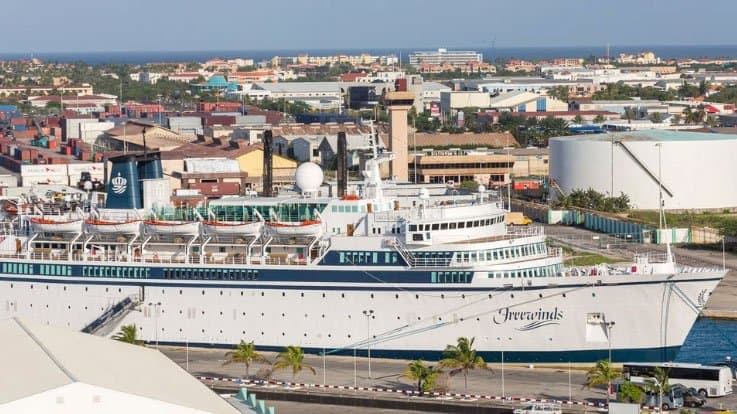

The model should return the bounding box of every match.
[152,342,681,363]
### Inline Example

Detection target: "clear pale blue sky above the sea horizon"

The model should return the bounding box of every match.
[0,0,737,53]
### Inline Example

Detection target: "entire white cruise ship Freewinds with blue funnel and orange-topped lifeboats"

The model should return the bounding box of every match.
[0,133,725,362]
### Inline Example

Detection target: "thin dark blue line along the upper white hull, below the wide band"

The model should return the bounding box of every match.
[0,276,722,292]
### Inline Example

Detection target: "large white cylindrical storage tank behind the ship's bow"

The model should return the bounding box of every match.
[550,130,737,210]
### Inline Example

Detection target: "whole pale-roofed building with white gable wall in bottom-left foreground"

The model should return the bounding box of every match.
[0,318,240,414]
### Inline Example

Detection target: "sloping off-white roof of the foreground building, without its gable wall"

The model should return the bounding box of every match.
[0,318,238,414]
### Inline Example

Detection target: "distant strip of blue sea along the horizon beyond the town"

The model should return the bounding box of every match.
[0,45,737,64]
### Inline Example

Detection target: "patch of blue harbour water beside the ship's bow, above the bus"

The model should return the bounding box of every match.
[676,318,737,364]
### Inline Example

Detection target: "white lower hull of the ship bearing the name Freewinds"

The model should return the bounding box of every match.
[0,258,723,362]
